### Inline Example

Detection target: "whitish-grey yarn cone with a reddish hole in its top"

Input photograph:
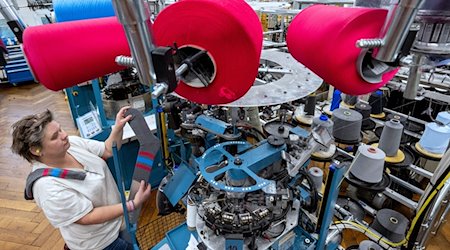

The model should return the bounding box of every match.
[350,145,386,183]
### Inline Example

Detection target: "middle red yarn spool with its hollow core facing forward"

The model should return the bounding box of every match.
[153,0,262,104]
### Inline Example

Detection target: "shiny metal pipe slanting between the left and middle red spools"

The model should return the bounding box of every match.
[112,0,156,86]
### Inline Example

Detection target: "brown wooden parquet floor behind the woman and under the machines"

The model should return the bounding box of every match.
[0,84,450,250]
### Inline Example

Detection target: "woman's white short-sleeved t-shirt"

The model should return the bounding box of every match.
[33,136,122,250]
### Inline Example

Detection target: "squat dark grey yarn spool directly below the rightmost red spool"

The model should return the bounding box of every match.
[333,108,362,141]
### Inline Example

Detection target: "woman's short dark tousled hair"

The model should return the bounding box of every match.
[11,109,53,162]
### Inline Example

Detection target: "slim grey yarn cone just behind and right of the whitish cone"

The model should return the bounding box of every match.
[378,120,403,156]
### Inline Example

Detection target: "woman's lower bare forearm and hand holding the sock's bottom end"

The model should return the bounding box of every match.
[75,181,151,225]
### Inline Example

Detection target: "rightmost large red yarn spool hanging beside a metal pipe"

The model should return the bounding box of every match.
[286,5,397,95]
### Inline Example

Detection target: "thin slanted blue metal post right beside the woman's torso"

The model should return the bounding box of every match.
[112,142,139,250]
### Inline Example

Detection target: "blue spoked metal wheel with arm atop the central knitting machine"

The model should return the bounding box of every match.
[196,141,286,192]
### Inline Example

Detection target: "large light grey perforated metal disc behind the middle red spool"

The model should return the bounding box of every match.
[222,50,322,107]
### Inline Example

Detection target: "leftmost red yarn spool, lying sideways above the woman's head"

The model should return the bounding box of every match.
[23,17,130,91]
